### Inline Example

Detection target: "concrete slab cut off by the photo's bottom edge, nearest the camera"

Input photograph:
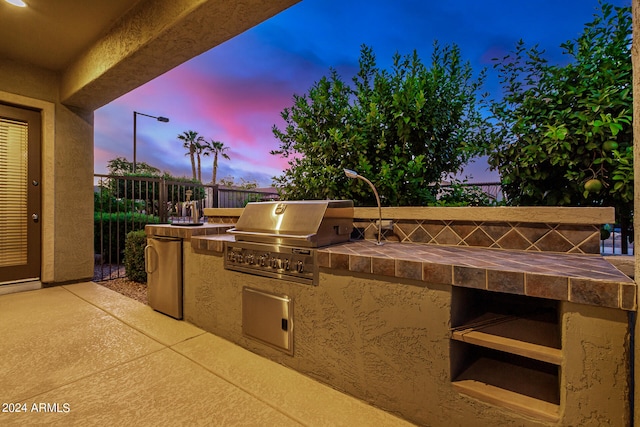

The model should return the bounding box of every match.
[13,348,300,426]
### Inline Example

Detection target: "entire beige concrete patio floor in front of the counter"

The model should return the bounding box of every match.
[0,282,410,426]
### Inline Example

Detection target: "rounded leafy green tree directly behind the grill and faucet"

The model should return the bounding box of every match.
[271,43,487,206]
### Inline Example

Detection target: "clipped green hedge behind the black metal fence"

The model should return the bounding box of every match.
[93,212,160,264]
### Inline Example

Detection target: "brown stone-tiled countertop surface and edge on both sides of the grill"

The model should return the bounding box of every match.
[186,234,637,311]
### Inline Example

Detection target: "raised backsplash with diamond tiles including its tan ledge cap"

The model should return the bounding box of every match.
[205,207,614,254]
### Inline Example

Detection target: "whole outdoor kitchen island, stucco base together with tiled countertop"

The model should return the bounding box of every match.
[183,235,635,426]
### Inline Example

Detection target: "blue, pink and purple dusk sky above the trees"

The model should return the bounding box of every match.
[94,0,631,186]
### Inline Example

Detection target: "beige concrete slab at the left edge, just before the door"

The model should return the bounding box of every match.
[0,288,163,404]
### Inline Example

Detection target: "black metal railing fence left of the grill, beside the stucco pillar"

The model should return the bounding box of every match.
[93,175,278,281]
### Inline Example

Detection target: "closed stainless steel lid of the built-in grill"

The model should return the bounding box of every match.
[227,200,353,247]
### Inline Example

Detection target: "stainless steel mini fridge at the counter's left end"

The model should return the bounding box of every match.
[144,236,182,319]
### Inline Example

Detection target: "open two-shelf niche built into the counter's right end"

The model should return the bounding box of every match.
[450,287,562,421]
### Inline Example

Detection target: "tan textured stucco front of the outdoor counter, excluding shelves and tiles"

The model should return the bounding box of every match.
[183,243,629,426]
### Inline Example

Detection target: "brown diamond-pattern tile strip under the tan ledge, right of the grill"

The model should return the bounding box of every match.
[353,220,600,254]
